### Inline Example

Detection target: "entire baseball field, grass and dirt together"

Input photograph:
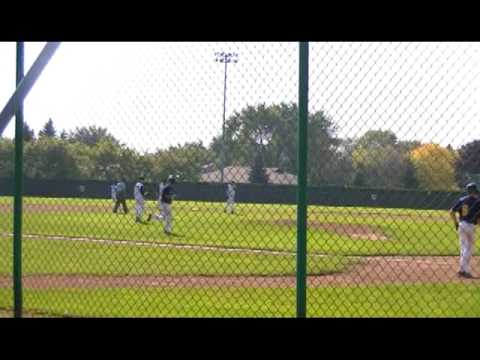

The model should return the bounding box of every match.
[0,197,480,317]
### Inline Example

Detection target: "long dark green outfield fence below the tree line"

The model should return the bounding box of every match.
[0,179,462,210]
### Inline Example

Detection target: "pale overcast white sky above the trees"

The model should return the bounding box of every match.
[0,42,480,151]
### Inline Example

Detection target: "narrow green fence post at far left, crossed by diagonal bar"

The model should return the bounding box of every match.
[13,42,24,318]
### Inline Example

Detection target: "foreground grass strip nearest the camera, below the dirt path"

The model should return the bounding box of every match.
[0,284,480,317]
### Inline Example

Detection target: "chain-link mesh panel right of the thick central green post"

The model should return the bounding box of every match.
[308,43,480,316]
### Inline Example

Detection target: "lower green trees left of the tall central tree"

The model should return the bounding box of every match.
[0,119,212,181]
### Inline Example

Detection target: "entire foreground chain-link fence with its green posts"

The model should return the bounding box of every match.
[0,42,480,317]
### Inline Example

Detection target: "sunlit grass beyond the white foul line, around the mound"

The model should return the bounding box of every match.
[0,198,464,255]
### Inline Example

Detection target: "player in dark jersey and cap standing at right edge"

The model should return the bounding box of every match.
[450,183,480,278]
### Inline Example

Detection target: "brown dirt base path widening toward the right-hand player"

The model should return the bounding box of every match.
[0,256,480,289]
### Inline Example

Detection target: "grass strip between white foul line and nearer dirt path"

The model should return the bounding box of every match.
[0,238,352,276]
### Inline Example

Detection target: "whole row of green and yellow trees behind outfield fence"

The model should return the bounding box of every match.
[0,103,480,191]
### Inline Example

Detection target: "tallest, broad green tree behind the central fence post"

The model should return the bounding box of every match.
[211,103,338,185]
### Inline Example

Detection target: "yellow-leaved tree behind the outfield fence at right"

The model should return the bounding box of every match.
[410,144,458,191]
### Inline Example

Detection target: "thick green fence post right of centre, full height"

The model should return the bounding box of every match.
[297,42,308,318]
